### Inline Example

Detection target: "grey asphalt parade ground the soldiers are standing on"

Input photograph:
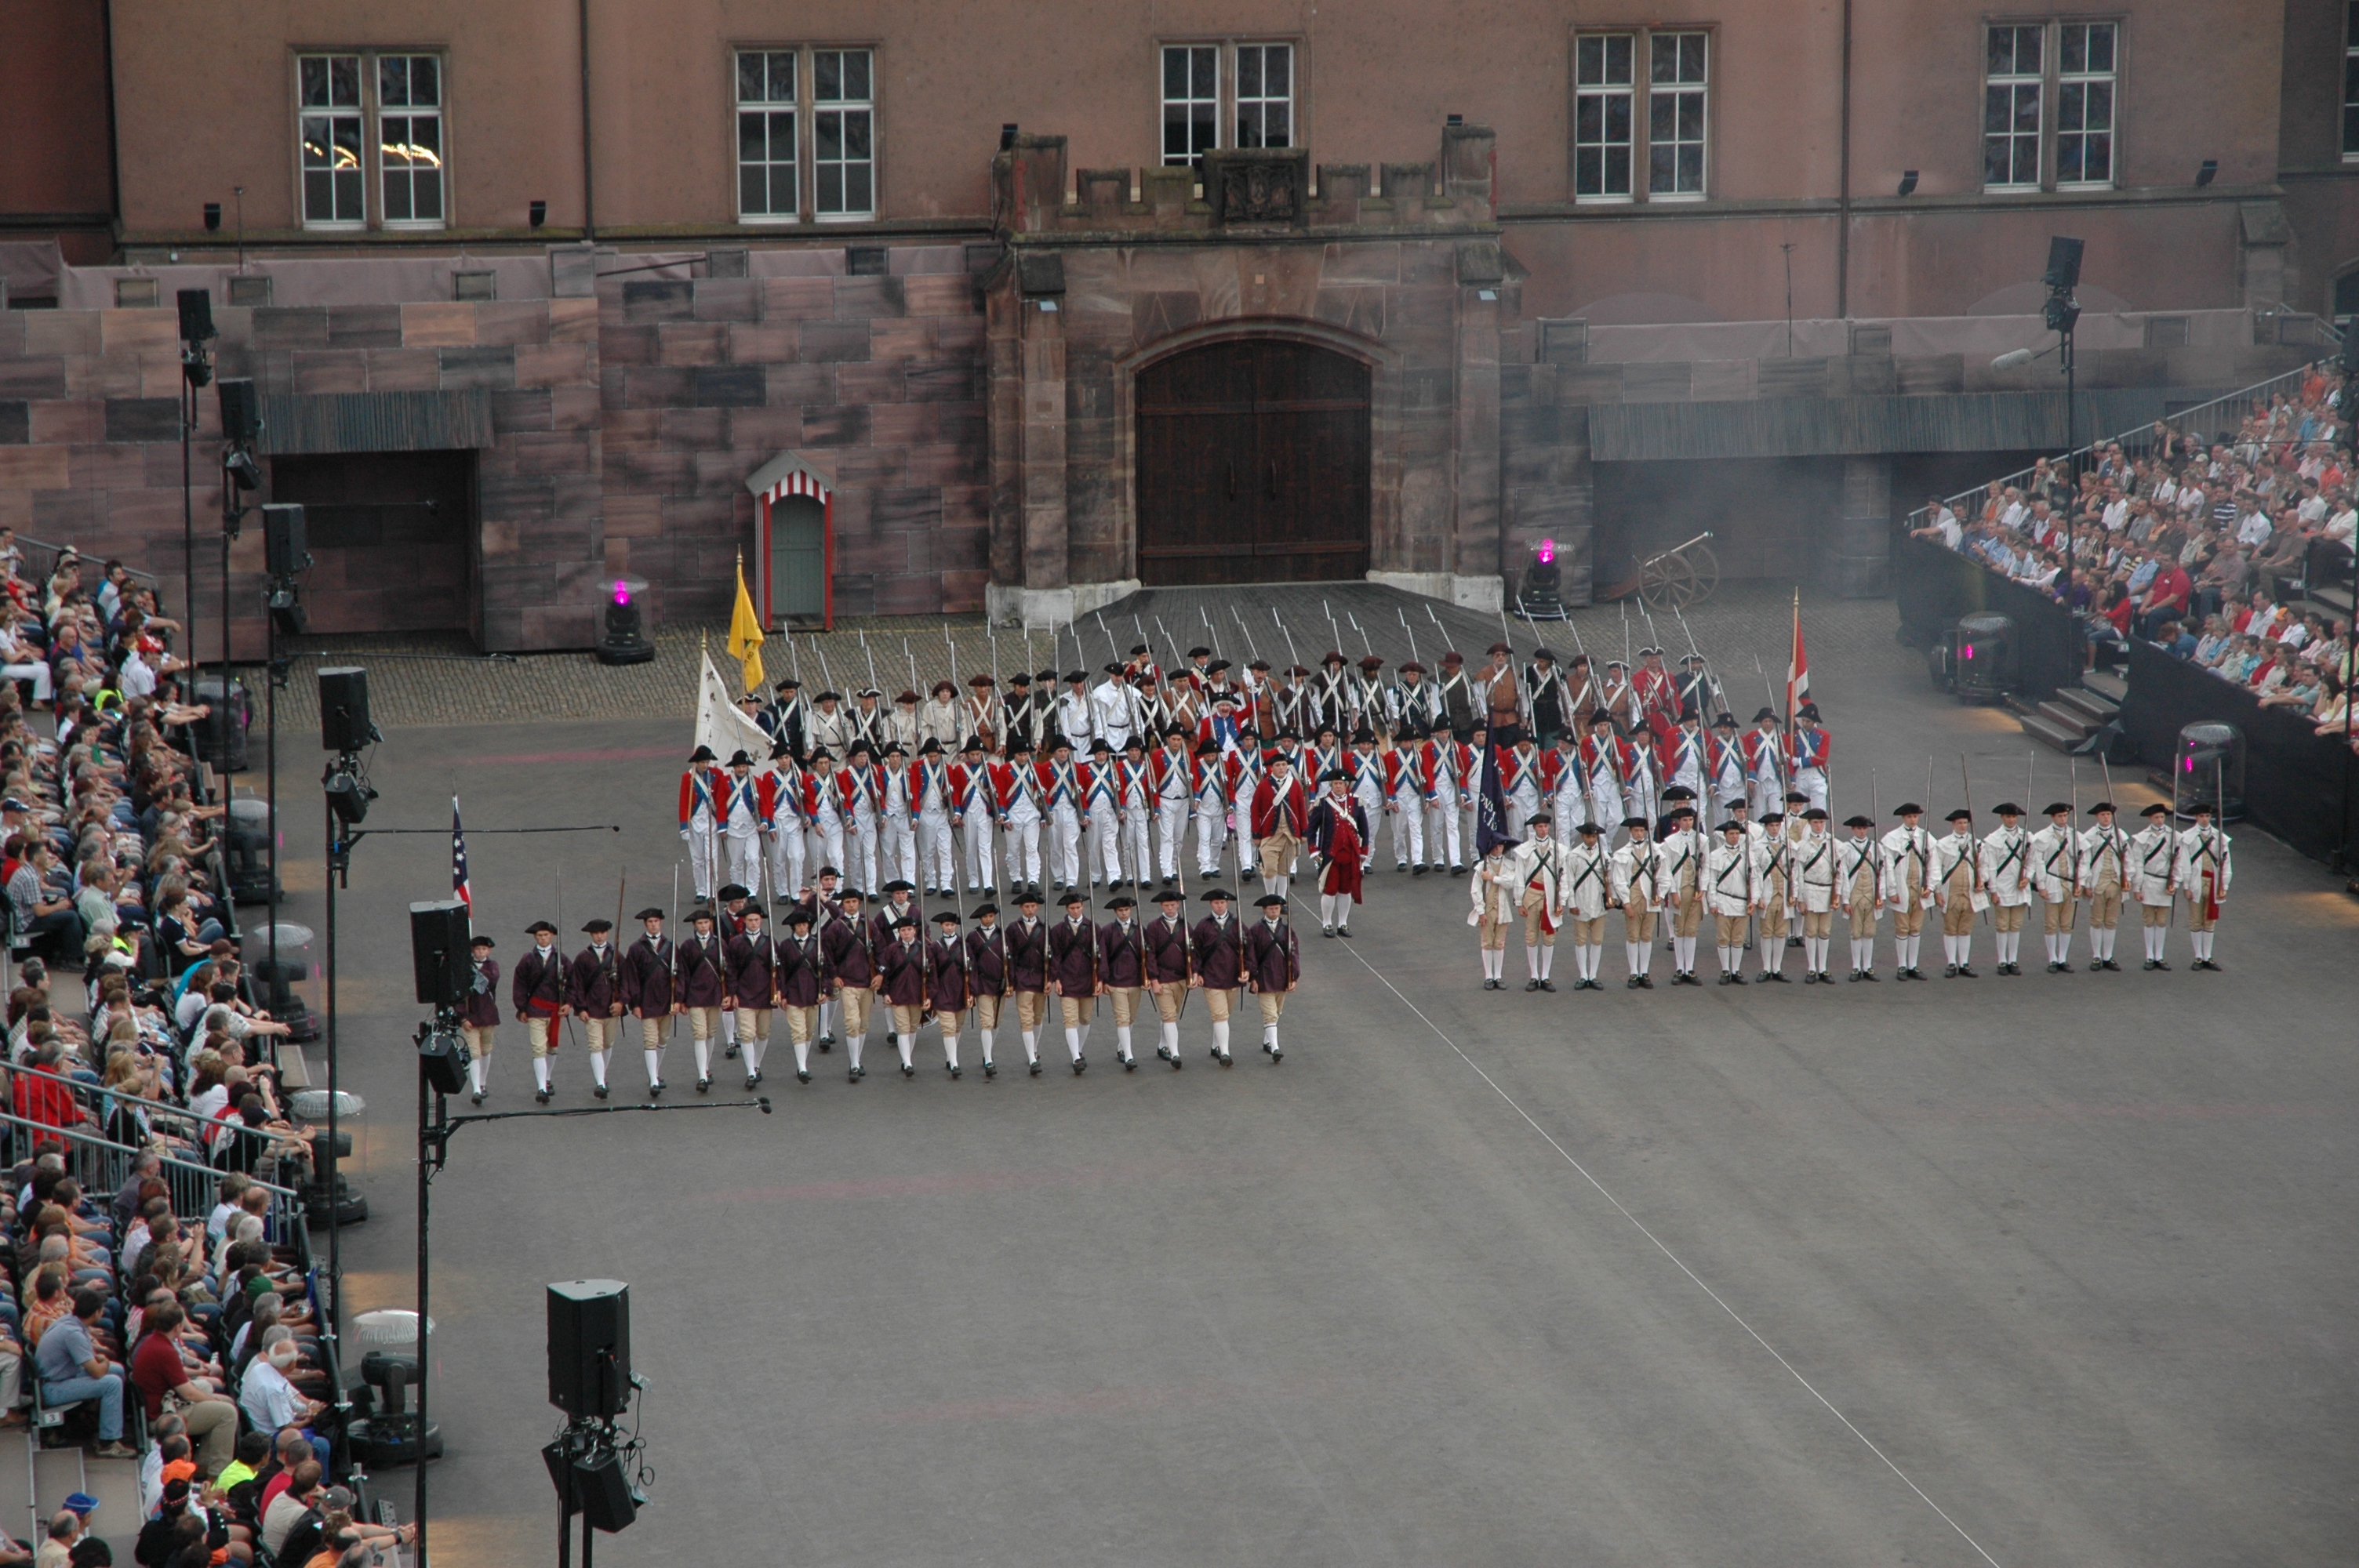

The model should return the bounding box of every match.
[283,589,2359,1568]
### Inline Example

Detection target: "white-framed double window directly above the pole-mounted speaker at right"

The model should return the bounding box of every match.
[1982,21,2121,191]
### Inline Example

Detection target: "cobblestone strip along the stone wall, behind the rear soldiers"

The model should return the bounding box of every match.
[263,583,1896,731]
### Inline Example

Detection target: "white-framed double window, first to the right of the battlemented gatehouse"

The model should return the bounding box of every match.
[1573,31,1713,201]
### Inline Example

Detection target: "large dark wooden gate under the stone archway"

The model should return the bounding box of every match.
[1137,337,1369,585]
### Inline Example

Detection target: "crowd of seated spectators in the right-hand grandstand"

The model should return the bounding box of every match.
[1913,363,2359,738]
